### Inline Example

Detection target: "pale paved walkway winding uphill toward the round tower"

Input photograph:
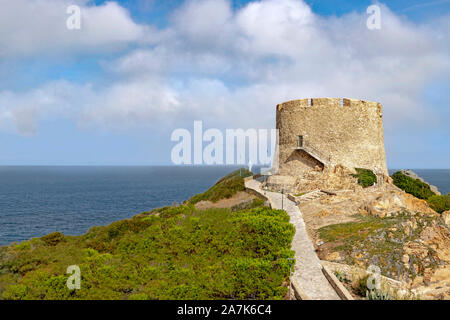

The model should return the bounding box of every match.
[245,180,340,300]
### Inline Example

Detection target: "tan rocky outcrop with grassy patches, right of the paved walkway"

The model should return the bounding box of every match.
[301,172,450,299]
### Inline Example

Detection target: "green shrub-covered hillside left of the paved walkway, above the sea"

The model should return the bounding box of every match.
[0,170,294,299]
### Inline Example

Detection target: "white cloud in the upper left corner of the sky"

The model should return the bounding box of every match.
[0,0,145,58]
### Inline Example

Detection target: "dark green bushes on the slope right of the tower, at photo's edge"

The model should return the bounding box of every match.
[392,171,450,213]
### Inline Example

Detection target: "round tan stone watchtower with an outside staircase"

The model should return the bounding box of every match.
[276,98,388,176]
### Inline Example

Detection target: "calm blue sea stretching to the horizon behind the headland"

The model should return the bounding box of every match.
[0,166,450,245]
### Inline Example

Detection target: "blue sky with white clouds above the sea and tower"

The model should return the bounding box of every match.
[0,0,450,168]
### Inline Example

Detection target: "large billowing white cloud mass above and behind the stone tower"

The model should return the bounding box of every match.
[100,0,449,130]
